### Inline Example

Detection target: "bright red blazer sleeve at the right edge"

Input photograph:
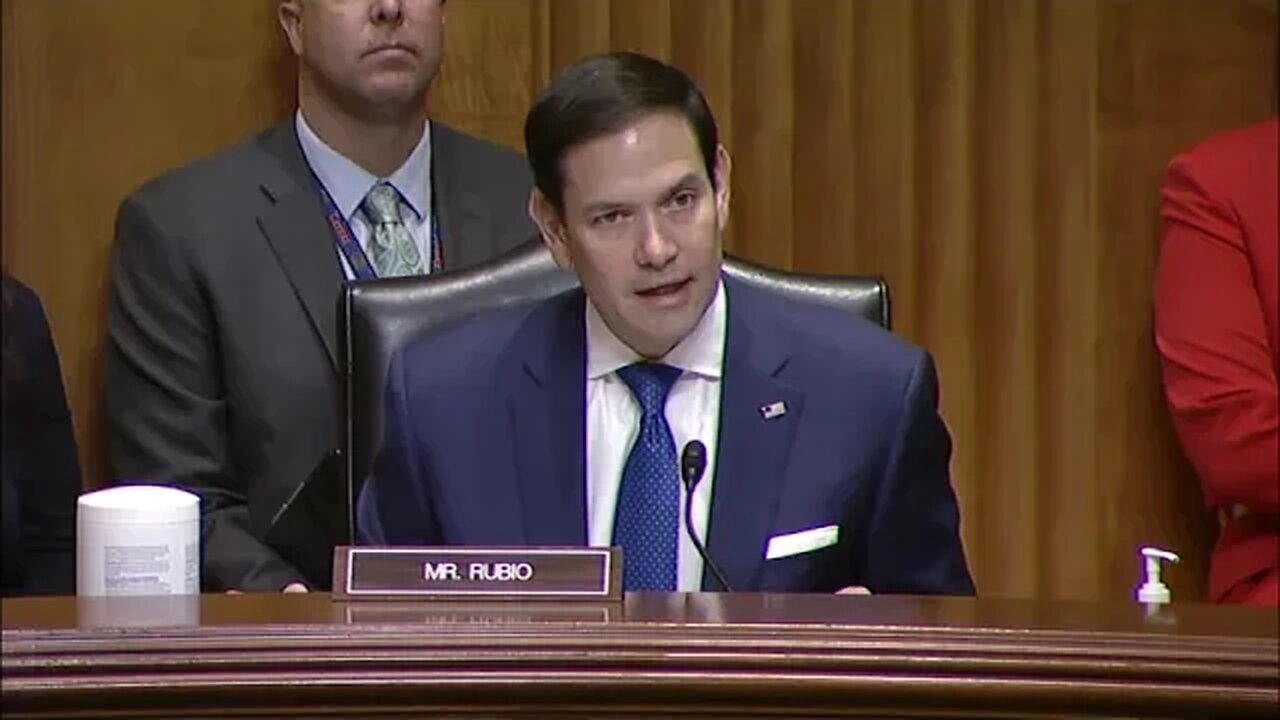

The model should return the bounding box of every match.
[1155,149,1280,511]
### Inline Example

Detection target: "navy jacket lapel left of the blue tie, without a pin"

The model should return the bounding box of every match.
[509,290,588,546]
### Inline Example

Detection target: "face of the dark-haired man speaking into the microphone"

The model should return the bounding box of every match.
[531,111,730,357]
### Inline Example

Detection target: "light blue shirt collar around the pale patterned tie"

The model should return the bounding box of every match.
[293,110,431,220]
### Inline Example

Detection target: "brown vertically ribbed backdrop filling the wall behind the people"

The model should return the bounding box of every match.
[3,0,1277,601]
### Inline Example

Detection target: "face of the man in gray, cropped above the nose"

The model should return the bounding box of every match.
[279,0,444,119]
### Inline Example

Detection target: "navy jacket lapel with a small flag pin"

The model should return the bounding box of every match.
[703,278,804,589]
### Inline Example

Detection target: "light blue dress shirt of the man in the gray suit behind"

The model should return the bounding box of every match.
[293,110,431,281]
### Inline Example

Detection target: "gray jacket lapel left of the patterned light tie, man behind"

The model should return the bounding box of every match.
[249,119,343,372]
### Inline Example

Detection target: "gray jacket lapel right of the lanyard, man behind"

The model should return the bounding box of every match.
[431,122,494,270]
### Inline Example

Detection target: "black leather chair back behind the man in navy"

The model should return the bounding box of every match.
[338,238,890,538]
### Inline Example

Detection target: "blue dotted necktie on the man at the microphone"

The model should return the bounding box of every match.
[613,363,680,591]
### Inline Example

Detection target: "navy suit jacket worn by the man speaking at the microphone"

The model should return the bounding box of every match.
[357,278,973,594]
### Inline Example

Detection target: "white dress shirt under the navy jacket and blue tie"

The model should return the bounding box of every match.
[586,282,728,592]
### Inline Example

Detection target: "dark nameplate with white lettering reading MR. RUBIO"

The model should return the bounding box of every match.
[333,546,622,602]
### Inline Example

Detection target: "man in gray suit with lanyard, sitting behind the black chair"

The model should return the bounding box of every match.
[106,0,535,592]
